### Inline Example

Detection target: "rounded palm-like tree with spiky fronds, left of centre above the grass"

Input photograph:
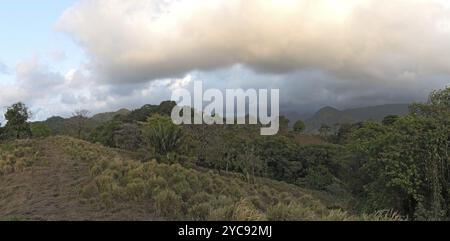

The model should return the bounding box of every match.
[143,114,184,155]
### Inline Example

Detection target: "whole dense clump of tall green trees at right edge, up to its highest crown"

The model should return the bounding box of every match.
[342,89,450,220]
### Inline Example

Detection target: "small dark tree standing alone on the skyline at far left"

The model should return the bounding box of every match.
[5,102,32,139]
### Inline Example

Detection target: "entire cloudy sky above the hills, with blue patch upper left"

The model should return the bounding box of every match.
[0,0,450,122]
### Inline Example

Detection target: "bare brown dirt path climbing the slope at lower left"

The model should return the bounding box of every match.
[0,140,155,220]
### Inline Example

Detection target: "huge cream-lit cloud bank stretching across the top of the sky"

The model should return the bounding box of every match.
[58,0,450,83]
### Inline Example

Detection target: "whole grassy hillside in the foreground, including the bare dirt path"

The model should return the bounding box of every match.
[0,136,395,220]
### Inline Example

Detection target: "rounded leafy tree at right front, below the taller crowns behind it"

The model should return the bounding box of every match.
[354,116,450,219]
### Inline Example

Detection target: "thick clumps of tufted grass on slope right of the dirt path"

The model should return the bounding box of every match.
[73,141,362,220]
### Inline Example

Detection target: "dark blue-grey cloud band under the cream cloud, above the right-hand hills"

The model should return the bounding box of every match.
[192,65,442,113]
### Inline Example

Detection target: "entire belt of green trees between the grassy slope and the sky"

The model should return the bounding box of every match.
[1,88,450,220]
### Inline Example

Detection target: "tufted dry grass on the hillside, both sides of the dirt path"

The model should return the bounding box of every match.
[0,136,400,221]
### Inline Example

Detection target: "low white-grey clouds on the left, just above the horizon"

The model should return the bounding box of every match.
[0,56,190,123]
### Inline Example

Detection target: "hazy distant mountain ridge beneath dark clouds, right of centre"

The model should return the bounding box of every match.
[305,104,409,130]
